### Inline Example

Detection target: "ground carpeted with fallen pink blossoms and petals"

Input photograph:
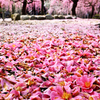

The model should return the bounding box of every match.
[0,19,100,100]
